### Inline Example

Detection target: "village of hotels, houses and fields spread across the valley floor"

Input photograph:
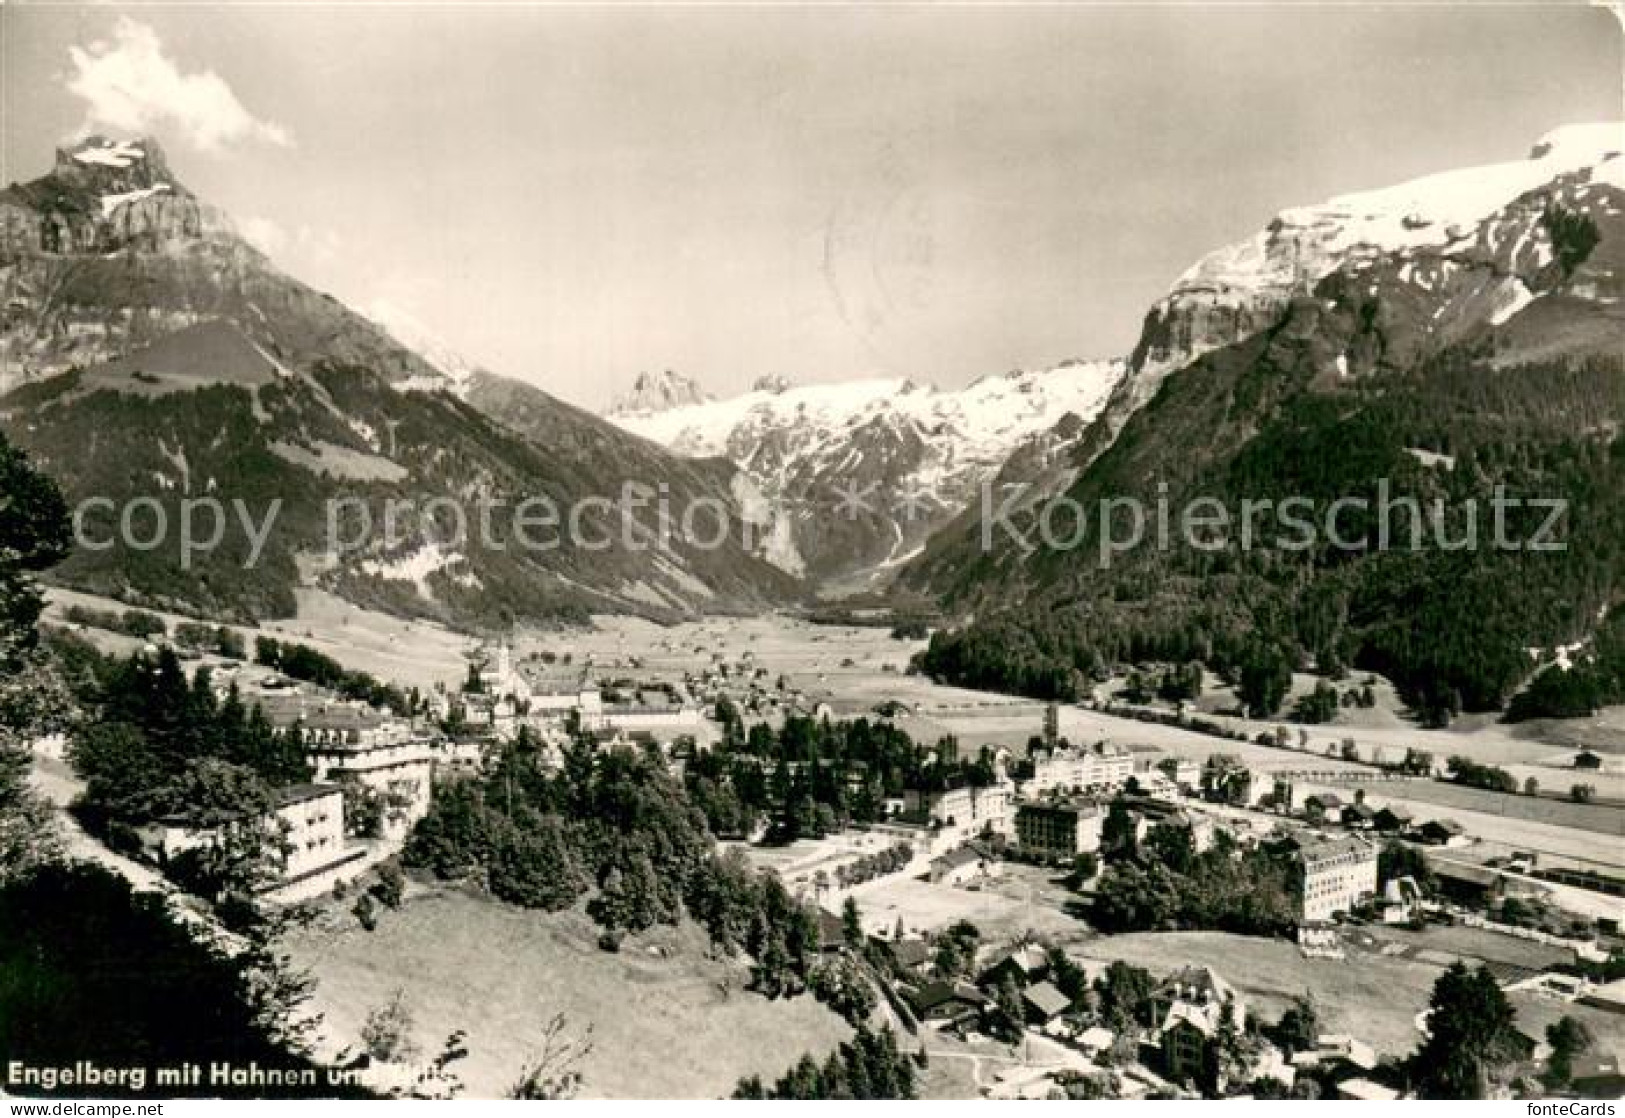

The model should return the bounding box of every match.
[25,595,1625,1099]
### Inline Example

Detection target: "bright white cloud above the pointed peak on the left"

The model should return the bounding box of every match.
[67,16,293,151]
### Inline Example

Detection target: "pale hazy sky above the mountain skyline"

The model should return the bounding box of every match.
[0,3,1622,406]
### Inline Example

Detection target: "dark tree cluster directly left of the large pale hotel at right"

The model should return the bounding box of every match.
[1090,801,1297,936]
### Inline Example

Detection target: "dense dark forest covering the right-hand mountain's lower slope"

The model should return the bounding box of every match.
[918,349,1625,725]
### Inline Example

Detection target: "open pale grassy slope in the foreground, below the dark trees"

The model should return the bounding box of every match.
[289,889,848,1099]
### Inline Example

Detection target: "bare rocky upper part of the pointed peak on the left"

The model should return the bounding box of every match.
[0,137,444,392]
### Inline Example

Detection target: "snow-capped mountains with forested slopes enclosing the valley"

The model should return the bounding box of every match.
[0,124,1625,734]
